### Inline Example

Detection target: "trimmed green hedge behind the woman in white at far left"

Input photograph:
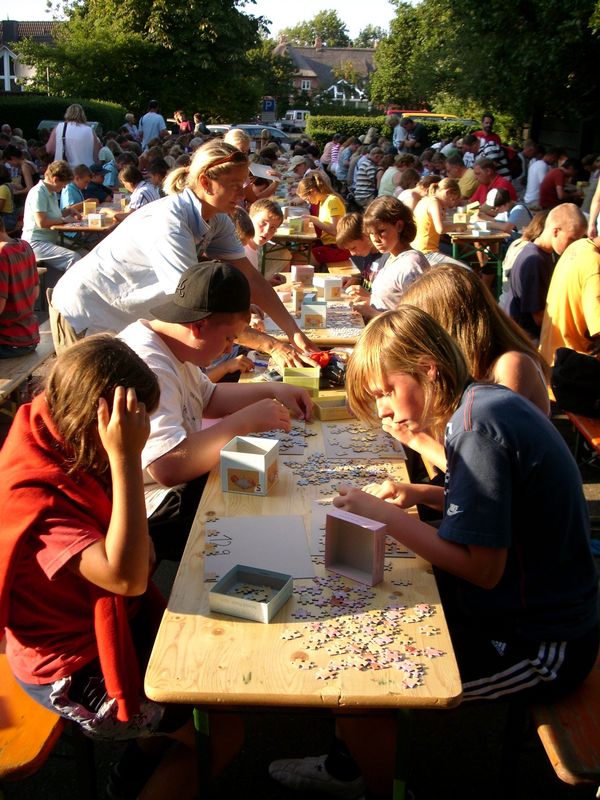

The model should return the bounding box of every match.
[0,93,127,139]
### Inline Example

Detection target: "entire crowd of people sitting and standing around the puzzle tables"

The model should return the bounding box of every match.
[0,101,600,800]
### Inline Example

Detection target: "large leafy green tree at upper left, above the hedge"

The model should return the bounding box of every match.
[18,0,262,116]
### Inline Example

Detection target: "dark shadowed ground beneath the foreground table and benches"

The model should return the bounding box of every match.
[5,410,600,800]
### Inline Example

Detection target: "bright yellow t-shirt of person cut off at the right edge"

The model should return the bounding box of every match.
[540,239,600,364]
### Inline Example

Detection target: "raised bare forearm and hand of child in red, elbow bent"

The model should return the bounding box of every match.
[69,386,150,595]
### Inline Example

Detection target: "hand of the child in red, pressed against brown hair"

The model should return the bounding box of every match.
[98,386,150,460]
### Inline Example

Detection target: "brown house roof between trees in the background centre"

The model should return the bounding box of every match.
[273,42,375,87]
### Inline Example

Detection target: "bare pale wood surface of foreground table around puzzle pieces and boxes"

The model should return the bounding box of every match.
[145,422,462,797]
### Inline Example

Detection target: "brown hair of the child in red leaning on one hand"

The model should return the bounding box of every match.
[45,333,160,477]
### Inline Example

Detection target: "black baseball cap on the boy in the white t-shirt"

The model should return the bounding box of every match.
[151,261,250,323]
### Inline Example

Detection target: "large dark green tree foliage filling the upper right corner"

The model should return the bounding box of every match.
[371,0,600,126]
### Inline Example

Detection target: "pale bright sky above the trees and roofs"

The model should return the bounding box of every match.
[9,0,394,39]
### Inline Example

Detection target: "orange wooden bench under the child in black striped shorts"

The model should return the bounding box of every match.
[532,654,600,786]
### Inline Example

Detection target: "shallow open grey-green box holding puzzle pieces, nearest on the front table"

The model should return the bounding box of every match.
[208,564,294,622]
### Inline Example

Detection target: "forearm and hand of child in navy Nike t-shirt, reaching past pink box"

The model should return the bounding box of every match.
[333,487,507,589]
